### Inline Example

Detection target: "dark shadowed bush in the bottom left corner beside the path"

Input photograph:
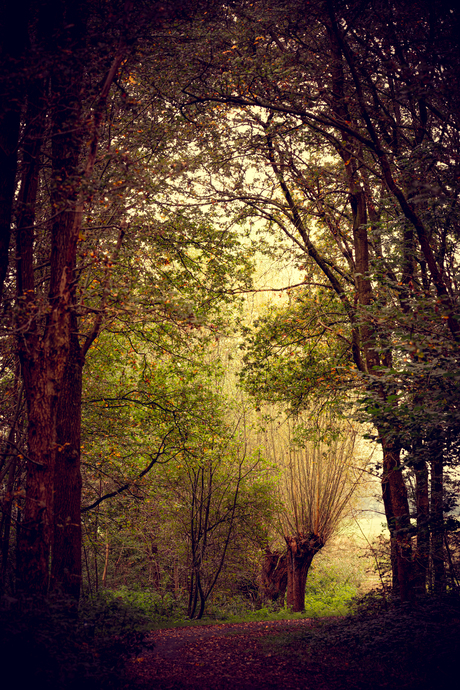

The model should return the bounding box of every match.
[0,595,147,690]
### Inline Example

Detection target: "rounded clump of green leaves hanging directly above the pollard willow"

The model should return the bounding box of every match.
[241,290,354,413]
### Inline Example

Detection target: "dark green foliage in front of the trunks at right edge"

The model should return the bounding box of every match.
[359,322,460,456]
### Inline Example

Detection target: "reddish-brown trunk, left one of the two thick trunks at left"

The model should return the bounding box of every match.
[16,74,58,595]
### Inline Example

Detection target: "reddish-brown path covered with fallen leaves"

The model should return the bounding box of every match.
[126,619,346,690]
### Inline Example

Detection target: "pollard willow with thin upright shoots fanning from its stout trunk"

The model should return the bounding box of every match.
[261,408,362,612]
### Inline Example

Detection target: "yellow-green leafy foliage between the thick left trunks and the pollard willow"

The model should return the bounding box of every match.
[79,325,274,615]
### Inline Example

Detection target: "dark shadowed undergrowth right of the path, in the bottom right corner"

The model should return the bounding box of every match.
[265,593,460,690]
